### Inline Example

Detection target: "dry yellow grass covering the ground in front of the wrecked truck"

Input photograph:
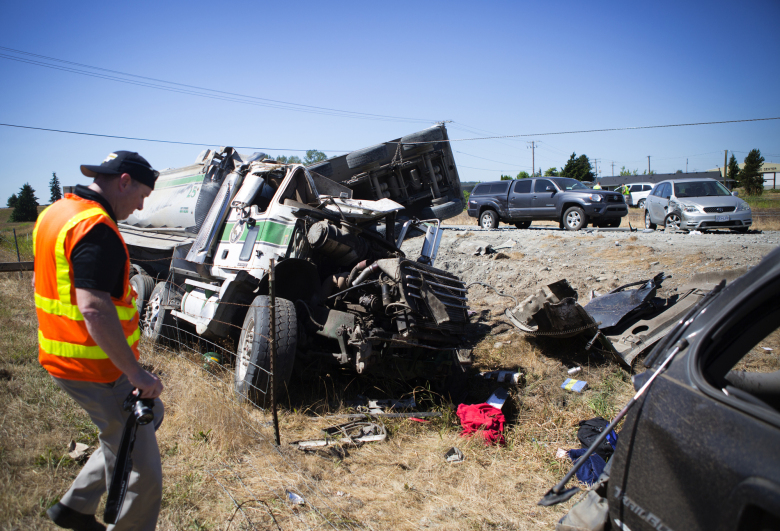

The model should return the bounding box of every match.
[0,268,630,530]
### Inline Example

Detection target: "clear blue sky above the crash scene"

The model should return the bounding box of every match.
[0,0,780,204]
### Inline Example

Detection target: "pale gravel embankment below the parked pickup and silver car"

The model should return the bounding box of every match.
[402,226,780,311]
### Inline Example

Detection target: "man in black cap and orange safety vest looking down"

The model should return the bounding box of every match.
[33,151,163,531]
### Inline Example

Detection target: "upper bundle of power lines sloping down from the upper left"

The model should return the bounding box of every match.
[0,46,435,123]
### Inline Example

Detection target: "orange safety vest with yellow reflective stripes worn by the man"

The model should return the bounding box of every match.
[33,194,141,383]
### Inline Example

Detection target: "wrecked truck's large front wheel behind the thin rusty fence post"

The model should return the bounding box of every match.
[235,295,298,408]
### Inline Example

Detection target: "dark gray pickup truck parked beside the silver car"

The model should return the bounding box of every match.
[468,177,628,230]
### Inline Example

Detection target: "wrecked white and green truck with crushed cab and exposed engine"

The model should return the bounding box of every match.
[119,141,470,405]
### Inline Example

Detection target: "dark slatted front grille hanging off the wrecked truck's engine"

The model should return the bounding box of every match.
[401,260,468,334]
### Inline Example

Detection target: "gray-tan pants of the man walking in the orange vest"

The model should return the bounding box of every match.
[54,375,163,531]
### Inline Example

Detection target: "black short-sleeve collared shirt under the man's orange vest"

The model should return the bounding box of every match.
[70,185,127,299]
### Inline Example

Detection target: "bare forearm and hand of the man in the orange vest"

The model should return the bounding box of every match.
[76,288,163,398]
